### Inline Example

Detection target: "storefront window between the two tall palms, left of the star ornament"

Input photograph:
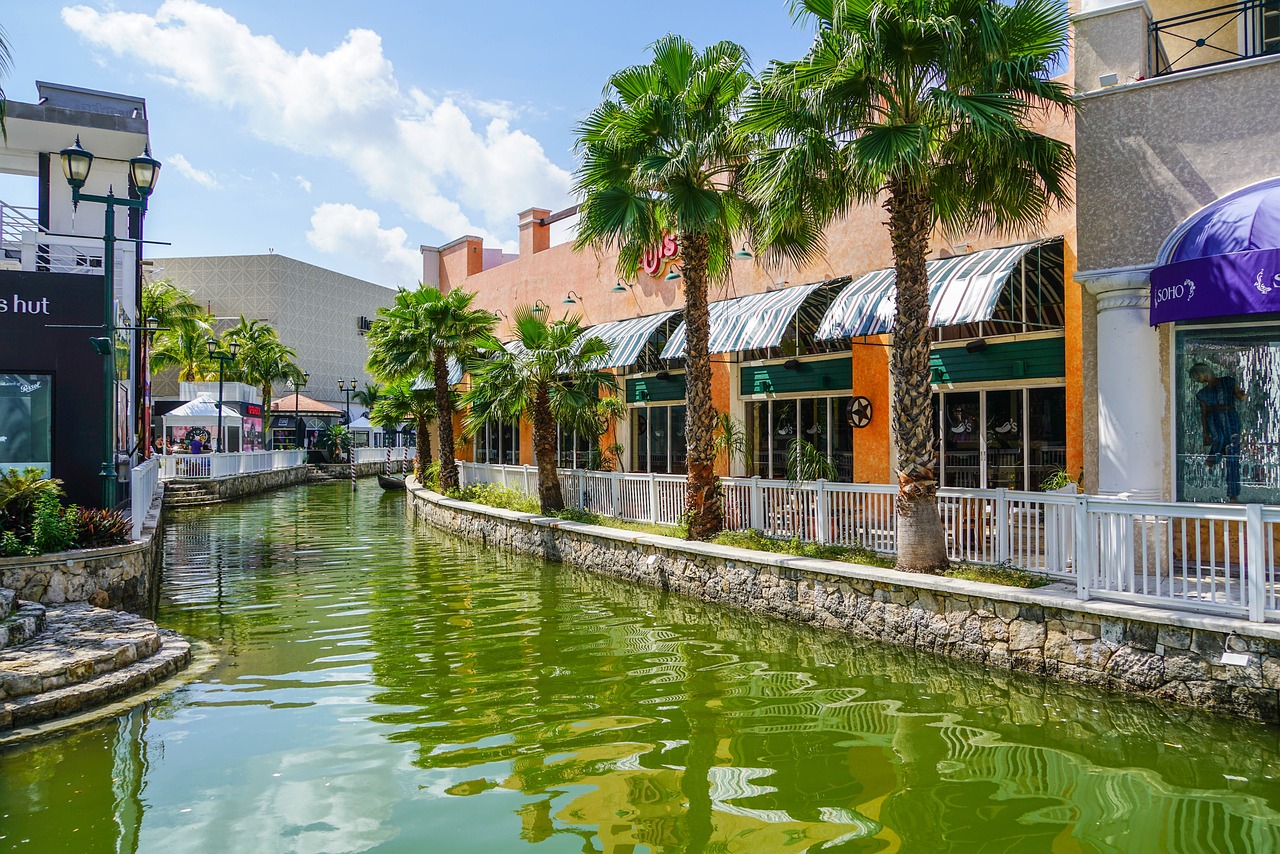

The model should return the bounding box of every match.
[746,397,854,483]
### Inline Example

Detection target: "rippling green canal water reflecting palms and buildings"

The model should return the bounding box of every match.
[0,481,1280,854]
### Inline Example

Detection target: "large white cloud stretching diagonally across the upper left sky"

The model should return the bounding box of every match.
[61,0,571,247]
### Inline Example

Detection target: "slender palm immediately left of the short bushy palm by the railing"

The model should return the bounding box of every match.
[369,286,498,489]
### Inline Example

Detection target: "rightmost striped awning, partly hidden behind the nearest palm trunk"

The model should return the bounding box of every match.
[815,241,1047,339]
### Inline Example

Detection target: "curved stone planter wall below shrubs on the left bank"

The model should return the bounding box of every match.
[0,485,164,616]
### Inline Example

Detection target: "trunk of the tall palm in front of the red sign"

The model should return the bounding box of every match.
[680,233,724,540]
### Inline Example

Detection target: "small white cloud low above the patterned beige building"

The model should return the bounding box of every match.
[307,202,422,288]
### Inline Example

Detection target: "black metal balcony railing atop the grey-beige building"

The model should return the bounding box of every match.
[1148,0,1280,77]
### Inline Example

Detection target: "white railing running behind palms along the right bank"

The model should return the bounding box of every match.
[458,462,1280,622]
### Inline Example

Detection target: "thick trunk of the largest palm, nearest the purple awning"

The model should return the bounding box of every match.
[884,179,947,572]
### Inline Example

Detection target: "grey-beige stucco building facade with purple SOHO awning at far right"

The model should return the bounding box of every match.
[1075,0,1280,504]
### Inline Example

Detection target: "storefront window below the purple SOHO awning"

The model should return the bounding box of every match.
[1174,325,1280,504]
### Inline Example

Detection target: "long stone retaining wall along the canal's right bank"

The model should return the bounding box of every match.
[407,480,1280,722]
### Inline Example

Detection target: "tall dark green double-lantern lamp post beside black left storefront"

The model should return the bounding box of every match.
[59,136,160,510]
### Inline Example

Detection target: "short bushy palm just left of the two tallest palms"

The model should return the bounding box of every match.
[462,312,617,513]
